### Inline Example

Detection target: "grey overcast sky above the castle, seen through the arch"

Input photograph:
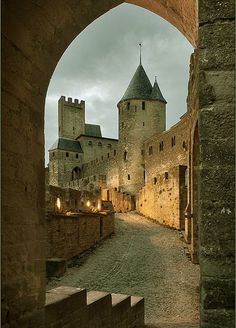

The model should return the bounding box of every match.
[45,4,193,164]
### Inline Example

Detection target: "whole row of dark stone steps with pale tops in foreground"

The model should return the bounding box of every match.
[45,286,144,328]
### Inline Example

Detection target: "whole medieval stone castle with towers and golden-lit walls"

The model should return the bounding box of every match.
[49,59,189,230]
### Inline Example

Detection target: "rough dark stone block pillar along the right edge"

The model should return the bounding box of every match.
[198,0,235,328]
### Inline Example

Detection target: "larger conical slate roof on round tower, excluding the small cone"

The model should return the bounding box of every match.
[121,64,152,101]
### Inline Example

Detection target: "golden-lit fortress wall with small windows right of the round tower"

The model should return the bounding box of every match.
[137,114,189,229]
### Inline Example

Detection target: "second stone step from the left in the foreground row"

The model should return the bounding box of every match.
[87,291,112,328]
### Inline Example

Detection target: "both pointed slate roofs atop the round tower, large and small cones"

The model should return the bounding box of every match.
[120,64,166,103]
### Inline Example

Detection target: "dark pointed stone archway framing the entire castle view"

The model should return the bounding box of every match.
[2,0,234,327]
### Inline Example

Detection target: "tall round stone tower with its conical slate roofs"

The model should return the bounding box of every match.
[117,61,166,195]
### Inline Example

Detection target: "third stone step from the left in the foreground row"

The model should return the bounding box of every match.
[111,294,131,328]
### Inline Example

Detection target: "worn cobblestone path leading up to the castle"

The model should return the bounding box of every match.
[47,212,199,328]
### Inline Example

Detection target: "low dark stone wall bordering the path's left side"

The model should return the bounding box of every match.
[46,212,114,259]
